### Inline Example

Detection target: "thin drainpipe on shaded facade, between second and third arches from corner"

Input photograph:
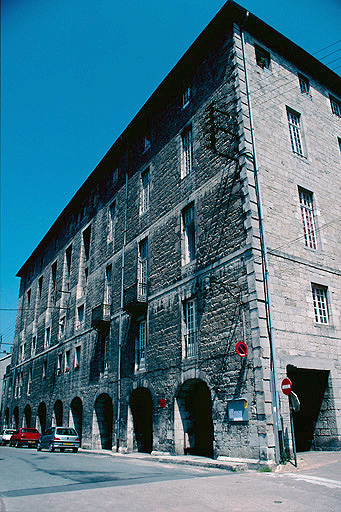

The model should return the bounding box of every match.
[116,170,128,452]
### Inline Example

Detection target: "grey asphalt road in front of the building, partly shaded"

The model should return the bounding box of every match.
[0,447,341,512]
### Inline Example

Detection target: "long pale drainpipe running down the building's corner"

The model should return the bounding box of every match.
[240,15,282,463]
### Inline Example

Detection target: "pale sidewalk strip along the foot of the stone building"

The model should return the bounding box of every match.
[80,449,341,473]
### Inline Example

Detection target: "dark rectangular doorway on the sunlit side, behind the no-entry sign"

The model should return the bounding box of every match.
[287,366,329,452]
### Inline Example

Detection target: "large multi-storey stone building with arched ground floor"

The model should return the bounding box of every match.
[1,2,341,460]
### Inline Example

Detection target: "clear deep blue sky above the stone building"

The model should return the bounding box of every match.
[0,0,341,350]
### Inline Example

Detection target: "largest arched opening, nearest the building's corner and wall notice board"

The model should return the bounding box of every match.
[177,379,214,458]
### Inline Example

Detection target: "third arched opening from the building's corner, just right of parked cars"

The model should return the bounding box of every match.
[92,393,113,450]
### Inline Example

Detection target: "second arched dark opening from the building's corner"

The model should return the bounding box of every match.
[129,388,153,453]
